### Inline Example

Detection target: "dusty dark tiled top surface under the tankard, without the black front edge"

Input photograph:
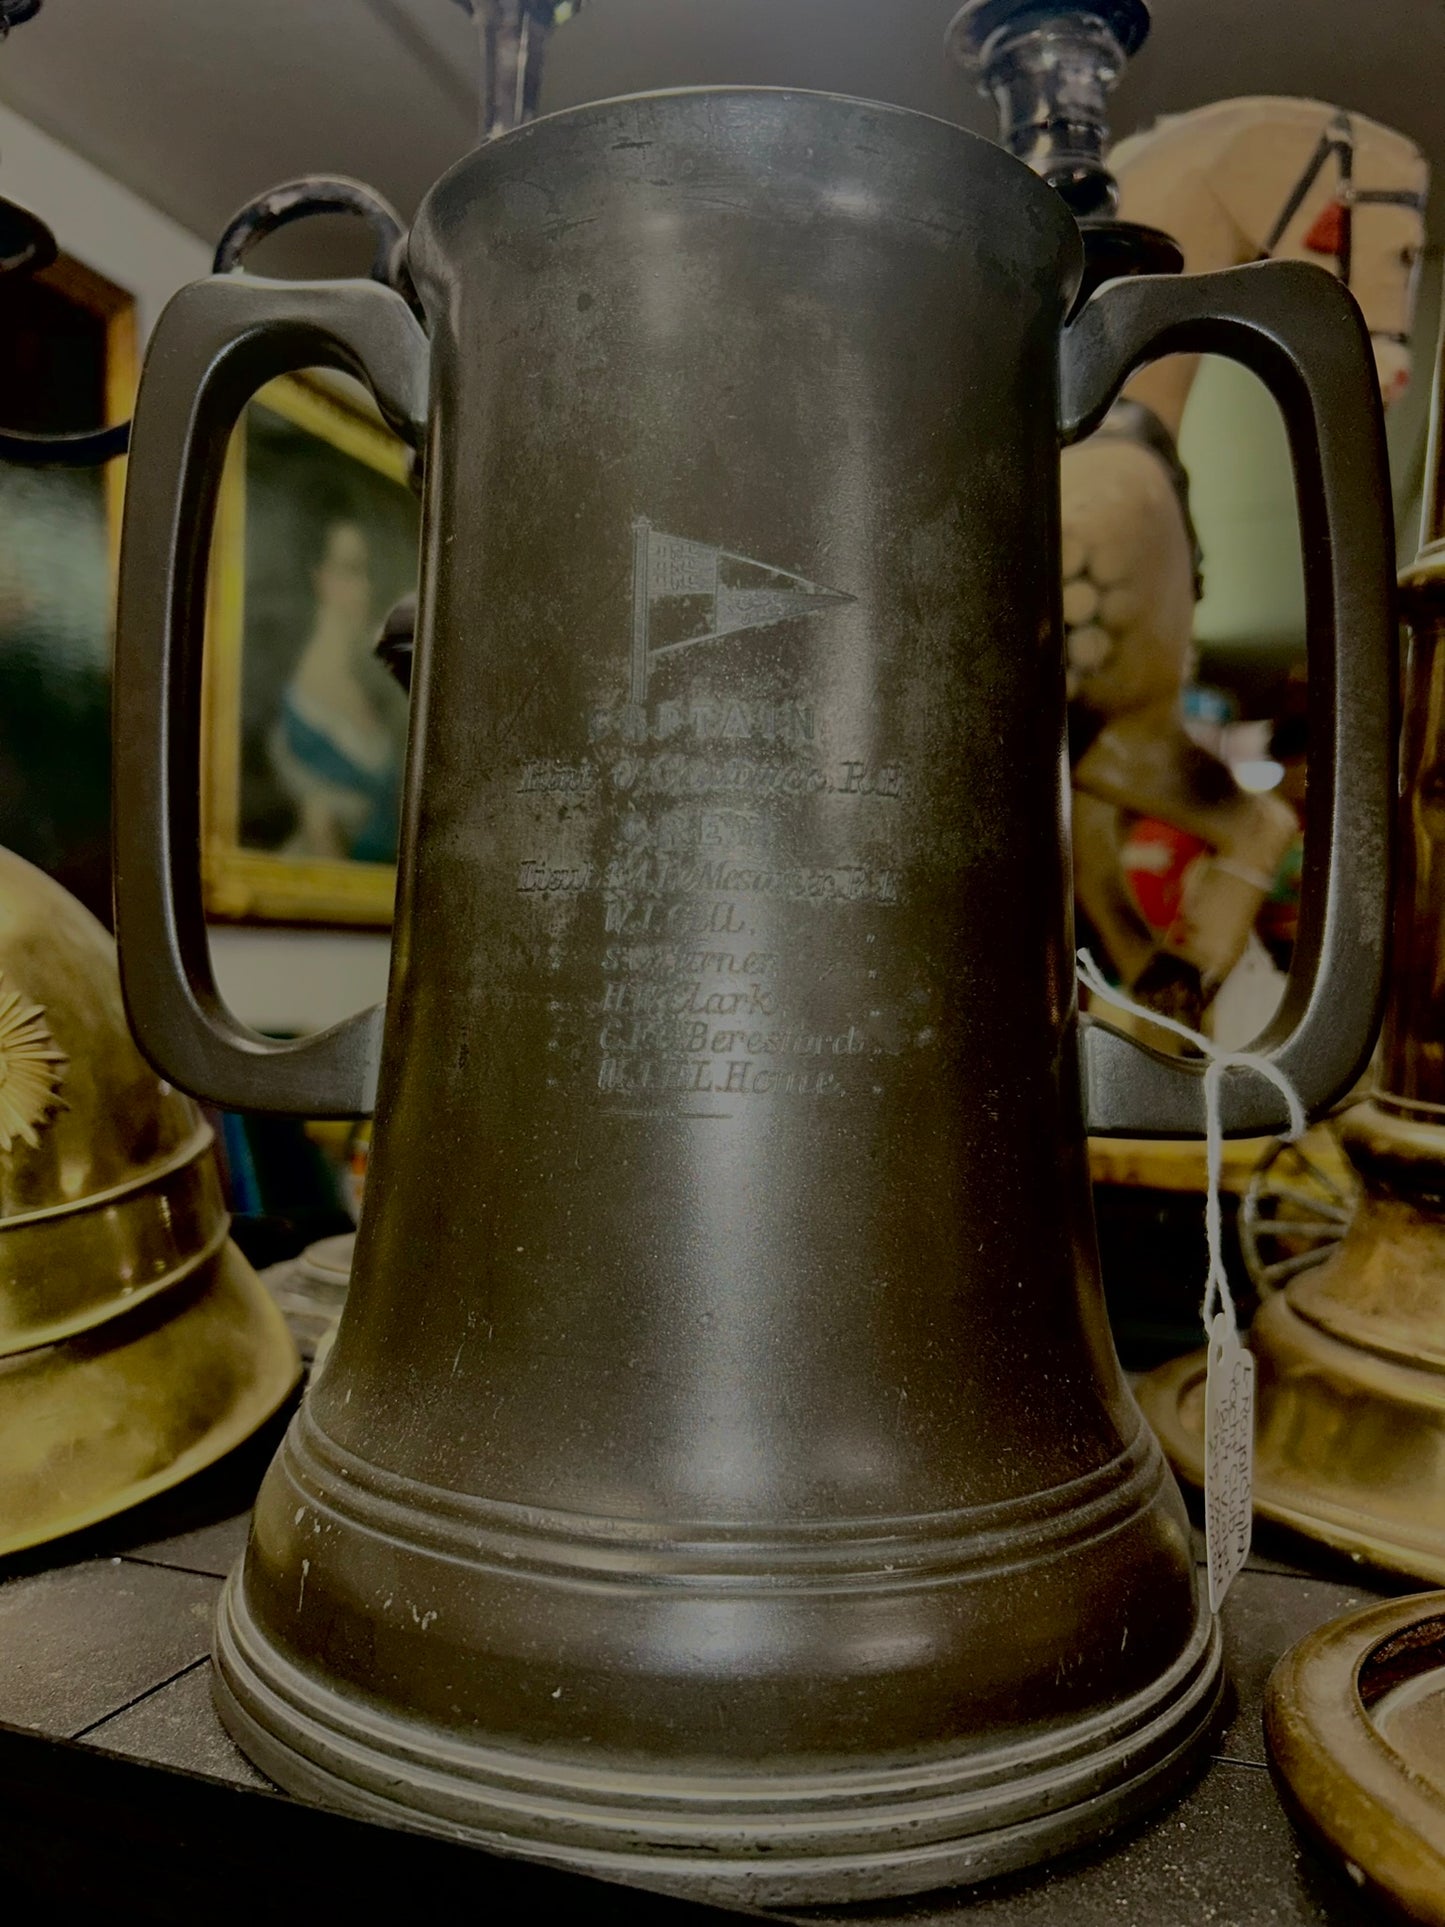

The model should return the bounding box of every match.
[0,1436,1410,1927]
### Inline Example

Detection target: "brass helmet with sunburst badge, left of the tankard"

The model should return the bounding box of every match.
[0,850,297,1553]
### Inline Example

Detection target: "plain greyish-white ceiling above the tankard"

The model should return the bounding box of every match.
[0,0,1445,270]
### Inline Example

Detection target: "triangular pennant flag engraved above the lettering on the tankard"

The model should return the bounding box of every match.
[632,515,855,703]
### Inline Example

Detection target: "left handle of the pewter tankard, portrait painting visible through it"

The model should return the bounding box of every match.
[112,277,428,1118]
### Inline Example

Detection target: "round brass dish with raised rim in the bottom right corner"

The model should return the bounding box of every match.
[1264,1592,1445,1927]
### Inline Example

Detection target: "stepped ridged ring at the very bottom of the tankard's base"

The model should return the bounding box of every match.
[214,1572,1222,1906]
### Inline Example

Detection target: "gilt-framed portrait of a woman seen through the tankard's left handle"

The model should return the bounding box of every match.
[202,376,420,927]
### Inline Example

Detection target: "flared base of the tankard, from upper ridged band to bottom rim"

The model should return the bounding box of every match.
[216,1422,1222,1906]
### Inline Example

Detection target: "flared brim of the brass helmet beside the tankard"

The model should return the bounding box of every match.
[0,1243,299,1553]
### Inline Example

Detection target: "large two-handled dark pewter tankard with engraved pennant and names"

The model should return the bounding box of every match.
[116,89,1391,1902]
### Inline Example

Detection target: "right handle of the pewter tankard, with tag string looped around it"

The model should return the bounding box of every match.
[1062,262,1395,1137]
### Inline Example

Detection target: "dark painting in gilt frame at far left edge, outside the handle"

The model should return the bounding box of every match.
[0,254,137,923]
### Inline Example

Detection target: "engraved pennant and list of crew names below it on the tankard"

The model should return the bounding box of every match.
[516,522,904,1116]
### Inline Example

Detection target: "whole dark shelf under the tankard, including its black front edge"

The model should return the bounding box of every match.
[0,1430,1414,1927]
